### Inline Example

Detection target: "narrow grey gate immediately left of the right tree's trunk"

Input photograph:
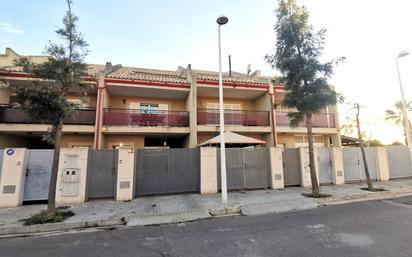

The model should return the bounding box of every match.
[282,149,300,186]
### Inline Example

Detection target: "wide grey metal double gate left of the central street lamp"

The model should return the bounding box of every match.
[135,148,200,196]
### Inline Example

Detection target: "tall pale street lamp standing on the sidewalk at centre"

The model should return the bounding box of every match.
[216,15,229,203]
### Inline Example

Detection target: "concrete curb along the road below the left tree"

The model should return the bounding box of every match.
[0,220,125,237]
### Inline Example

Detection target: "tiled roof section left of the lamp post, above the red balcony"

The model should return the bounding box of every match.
[107,67,189,83]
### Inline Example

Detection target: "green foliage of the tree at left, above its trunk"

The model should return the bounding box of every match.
[12,0,88,143]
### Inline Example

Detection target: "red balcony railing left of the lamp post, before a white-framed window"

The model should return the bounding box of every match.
[103,108,189,127]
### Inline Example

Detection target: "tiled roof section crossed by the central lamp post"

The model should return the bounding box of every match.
[193,70,268,85]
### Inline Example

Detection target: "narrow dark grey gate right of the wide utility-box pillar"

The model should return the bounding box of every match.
[86,149,119,198]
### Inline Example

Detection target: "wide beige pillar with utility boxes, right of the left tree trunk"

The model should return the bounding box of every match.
[56,147,89,204]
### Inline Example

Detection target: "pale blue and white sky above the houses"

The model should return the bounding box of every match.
[0,0,412,143]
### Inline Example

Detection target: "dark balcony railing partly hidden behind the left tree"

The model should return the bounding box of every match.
[0,105,96,125]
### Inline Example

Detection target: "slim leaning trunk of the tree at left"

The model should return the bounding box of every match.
[47,119,63,216]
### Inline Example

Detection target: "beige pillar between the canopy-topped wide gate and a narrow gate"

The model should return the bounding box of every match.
[269,147,285,190]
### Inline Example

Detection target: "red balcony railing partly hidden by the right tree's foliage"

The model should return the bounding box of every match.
[275,111,335,128]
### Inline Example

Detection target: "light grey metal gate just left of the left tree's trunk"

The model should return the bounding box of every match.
[23,150,54,201]
